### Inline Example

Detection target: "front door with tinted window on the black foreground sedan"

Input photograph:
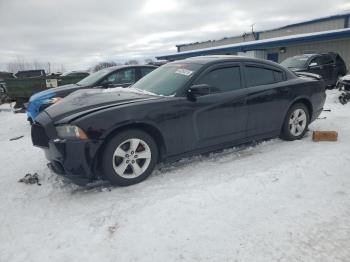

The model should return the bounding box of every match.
[189,63,248,148]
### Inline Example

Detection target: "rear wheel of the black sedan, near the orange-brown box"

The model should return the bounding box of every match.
[281,103,310,141]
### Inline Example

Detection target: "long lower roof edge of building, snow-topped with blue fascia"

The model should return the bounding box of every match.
[157,28,350,60]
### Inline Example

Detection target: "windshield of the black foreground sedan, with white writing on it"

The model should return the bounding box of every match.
[132,63,202,96]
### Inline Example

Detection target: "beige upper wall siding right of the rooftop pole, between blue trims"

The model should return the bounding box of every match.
[259,18,344,39]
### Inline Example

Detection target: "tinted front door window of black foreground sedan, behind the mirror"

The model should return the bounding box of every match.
[196,66,241,93]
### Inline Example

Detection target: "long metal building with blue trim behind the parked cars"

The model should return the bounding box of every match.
[157,13,350,68]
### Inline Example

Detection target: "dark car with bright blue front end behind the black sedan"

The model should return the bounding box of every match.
[27,65,157,122]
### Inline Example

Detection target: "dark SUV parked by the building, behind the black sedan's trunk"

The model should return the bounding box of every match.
[281,53,347,87]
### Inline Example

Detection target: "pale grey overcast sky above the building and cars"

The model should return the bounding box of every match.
[0,0,350,70]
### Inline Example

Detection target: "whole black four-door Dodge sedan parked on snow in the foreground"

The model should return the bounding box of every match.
[32,56,326,186]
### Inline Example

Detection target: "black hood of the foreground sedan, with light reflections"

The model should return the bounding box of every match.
[45,88,162,121]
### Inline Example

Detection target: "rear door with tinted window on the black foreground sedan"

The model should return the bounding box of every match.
[244,63,289,137]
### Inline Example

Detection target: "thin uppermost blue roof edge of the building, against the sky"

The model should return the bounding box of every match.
[176,11,350,47]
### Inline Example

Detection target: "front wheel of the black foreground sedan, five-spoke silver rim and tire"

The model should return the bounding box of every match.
[102,130,158,186]
